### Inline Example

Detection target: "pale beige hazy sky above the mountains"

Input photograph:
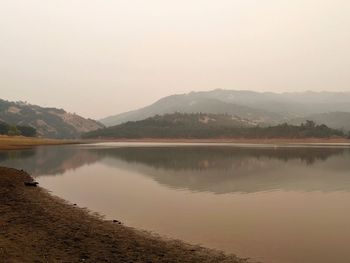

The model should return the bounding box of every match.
[0,0,350,118]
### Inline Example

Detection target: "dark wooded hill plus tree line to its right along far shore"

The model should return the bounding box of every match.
[83,113,346,139]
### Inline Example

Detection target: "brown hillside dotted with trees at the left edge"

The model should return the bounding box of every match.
[0,99,104,139]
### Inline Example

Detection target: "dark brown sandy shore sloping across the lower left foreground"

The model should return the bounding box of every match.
[0,167,247,263]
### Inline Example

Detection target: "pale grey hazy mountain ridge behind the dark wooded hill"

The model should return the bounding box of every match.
[100,89,350,126]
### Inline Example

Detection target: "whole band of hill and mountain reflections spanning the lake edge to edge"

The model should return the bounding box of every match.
[0,146,350,193]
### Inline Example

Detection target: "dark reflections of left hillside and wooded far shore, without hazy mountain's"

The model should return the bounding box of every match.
[0,146,348,175]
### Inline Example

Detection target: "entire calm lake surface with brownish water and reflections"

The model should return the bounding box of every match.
[0,144,350,263]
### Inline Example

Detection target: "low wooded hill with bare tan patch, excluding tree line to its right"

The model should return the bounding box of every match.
[87,113,257,138]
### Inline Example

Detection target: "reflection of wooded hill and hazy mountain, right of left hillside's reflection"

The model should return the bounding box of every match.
[95,147,350,193]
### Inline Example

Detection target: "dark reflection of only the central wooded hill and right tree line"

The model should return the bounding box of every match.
[92,146,348,170]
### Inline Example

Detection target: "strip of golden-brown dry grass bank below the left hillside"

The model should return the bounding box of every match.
[0,136,78,150]
